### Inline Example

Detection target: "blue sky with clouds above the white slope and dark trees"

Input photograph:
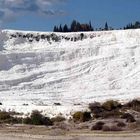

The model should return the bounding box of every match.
[0,0,140,31]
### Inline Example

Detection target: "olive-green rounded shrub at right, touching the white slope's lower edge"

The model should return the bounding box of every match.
[102,100,121,111]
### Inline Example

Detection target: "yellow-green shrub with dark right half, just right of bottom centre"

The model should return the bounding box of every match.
[73,111,91,122]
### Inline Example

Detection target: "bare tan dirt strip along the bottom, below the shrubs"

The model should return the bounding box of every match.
[0,125,140,140]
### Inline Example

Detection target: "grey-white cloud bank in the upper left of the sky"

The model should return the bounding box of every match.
[0,0,67,22]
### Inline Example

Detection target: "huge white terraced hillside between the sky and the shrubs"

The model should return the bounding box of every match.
[0,30,140,113]
